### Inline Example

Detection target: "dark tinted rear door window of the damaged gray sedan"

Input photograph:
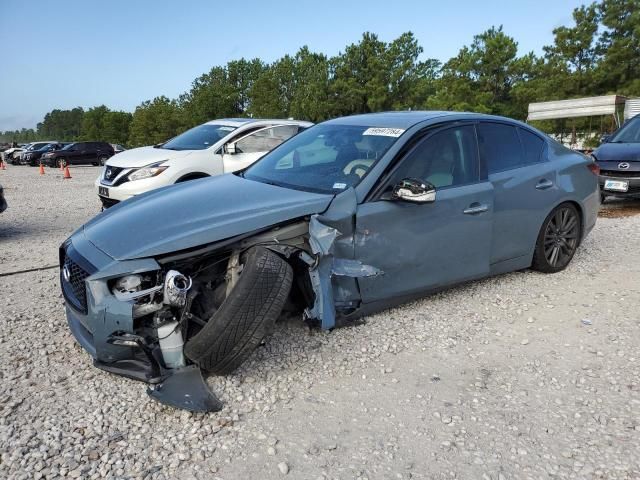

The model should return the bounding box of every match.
[478,123,524,173]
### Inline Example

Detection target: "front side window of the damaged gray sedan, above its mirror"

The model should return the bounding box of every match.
[389,126,479,188]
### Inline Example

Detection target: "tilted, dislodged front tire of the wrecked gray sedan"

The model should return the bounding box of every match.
[184,247,293,375]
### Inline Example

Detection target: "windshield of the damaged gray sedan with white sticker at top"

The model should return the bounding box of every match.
[243,124,404,193]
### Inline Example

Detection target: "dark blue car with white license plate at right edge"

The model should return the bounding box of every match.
[593,115,640,202]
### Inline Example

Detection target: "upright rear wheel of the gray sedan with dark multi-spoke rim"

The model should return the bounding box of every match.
[531,203,582,273]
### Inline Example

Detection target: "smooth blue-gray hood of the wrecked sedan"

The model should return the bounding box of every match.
[78,174,333,260]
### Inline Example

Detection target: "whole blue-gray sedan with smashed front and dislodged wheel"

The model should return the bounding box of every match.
[60,112,599,411]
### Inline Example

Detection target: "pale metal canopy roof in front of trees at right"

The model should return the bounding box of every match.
[527,95,626,126]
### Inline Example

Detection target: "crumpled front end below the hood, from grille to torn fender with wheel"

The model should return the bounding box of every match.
[60,189,383,411]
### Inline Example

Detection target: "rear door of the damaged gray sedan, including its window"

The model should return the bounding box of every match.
[477,122,560,264]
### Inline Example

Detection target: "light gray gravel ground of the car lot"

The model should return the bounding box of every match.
[0,166,640,480]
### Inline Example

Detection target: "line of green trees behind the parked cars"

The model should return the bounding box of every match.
[0,0,640,147]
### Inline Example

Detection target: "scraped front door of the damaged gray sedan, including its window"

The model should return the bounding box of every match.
[355,125,493,303]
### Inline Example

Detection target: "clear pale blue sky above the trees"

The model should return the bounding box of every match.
[0,0,584,130]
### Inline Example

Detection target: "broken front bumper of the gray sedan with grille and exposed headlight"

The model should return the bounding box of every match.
[60,232,222,411]
